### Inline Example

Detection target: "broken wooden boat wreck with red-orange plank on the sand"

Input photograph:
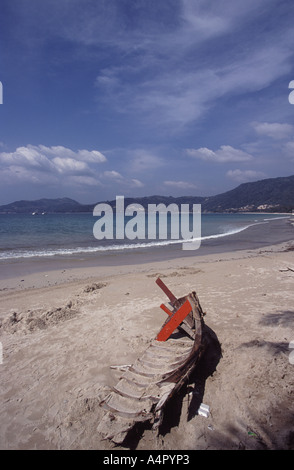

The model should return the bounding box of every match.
[97,278,207,444]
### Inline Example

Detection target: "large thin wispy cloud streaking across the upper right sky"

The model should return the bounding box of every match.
[96,24,292,133]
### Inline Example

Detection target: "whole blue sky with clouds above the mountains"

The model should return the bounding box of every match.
[0,0,294,205]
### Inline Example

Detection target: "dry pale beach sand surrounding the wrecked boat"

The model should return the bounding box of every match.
[0,242,294,450]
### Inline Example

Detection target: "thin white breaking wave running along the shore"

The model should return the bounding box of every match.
[0,219,271,260]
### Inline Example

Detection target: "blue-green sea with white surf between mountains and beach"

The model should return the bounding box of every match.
[0,213,293,263]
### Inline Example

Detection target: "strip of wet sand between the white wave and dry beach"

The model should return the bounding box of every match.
[0,219,294,291]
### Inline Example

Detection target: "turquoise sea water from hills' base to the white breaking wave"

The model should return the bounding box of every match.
[0,213,287,260]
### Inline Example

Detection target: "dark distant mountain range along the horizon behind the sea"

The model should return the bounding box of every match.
[0,175,294,214]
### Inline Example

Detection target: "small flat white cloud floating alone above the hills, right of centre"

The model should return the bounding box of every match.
[186,145,253,163]
